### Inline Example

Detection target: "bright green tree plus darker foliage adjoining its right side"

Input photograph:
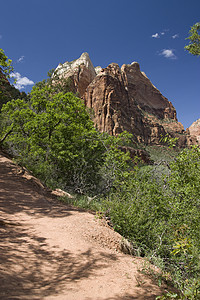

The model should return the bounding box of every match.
[1,81,133,193]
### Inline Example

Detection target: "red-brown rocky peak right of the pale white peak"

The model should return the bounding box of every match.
[84,62,184,144]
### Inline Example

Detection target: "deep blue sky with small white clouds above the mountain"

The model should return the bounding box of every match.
[0,0,200,128]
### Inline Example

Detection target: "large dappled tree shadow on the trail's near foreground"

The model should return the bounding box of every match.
[0,220,117,299]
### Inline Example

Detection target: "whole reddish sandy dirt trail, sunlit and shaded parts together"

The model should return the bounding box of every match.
[0,155,164,300]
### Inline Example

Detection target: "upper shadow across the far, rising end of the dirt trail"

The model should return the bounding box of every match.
[0,155,81,218]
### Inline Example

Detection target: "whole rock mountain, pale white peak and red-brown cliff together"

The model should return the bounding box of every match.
[56,53,198,146]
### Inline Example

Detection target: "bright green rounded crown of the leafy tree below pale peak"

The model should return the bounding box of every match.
[2,85,98,191]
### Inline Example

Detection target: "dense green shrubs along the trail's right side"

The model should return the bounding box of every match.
[104,146,200,289]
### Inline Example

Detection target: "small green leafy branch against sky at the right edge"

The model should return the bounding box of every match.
[185,22,200,56]
